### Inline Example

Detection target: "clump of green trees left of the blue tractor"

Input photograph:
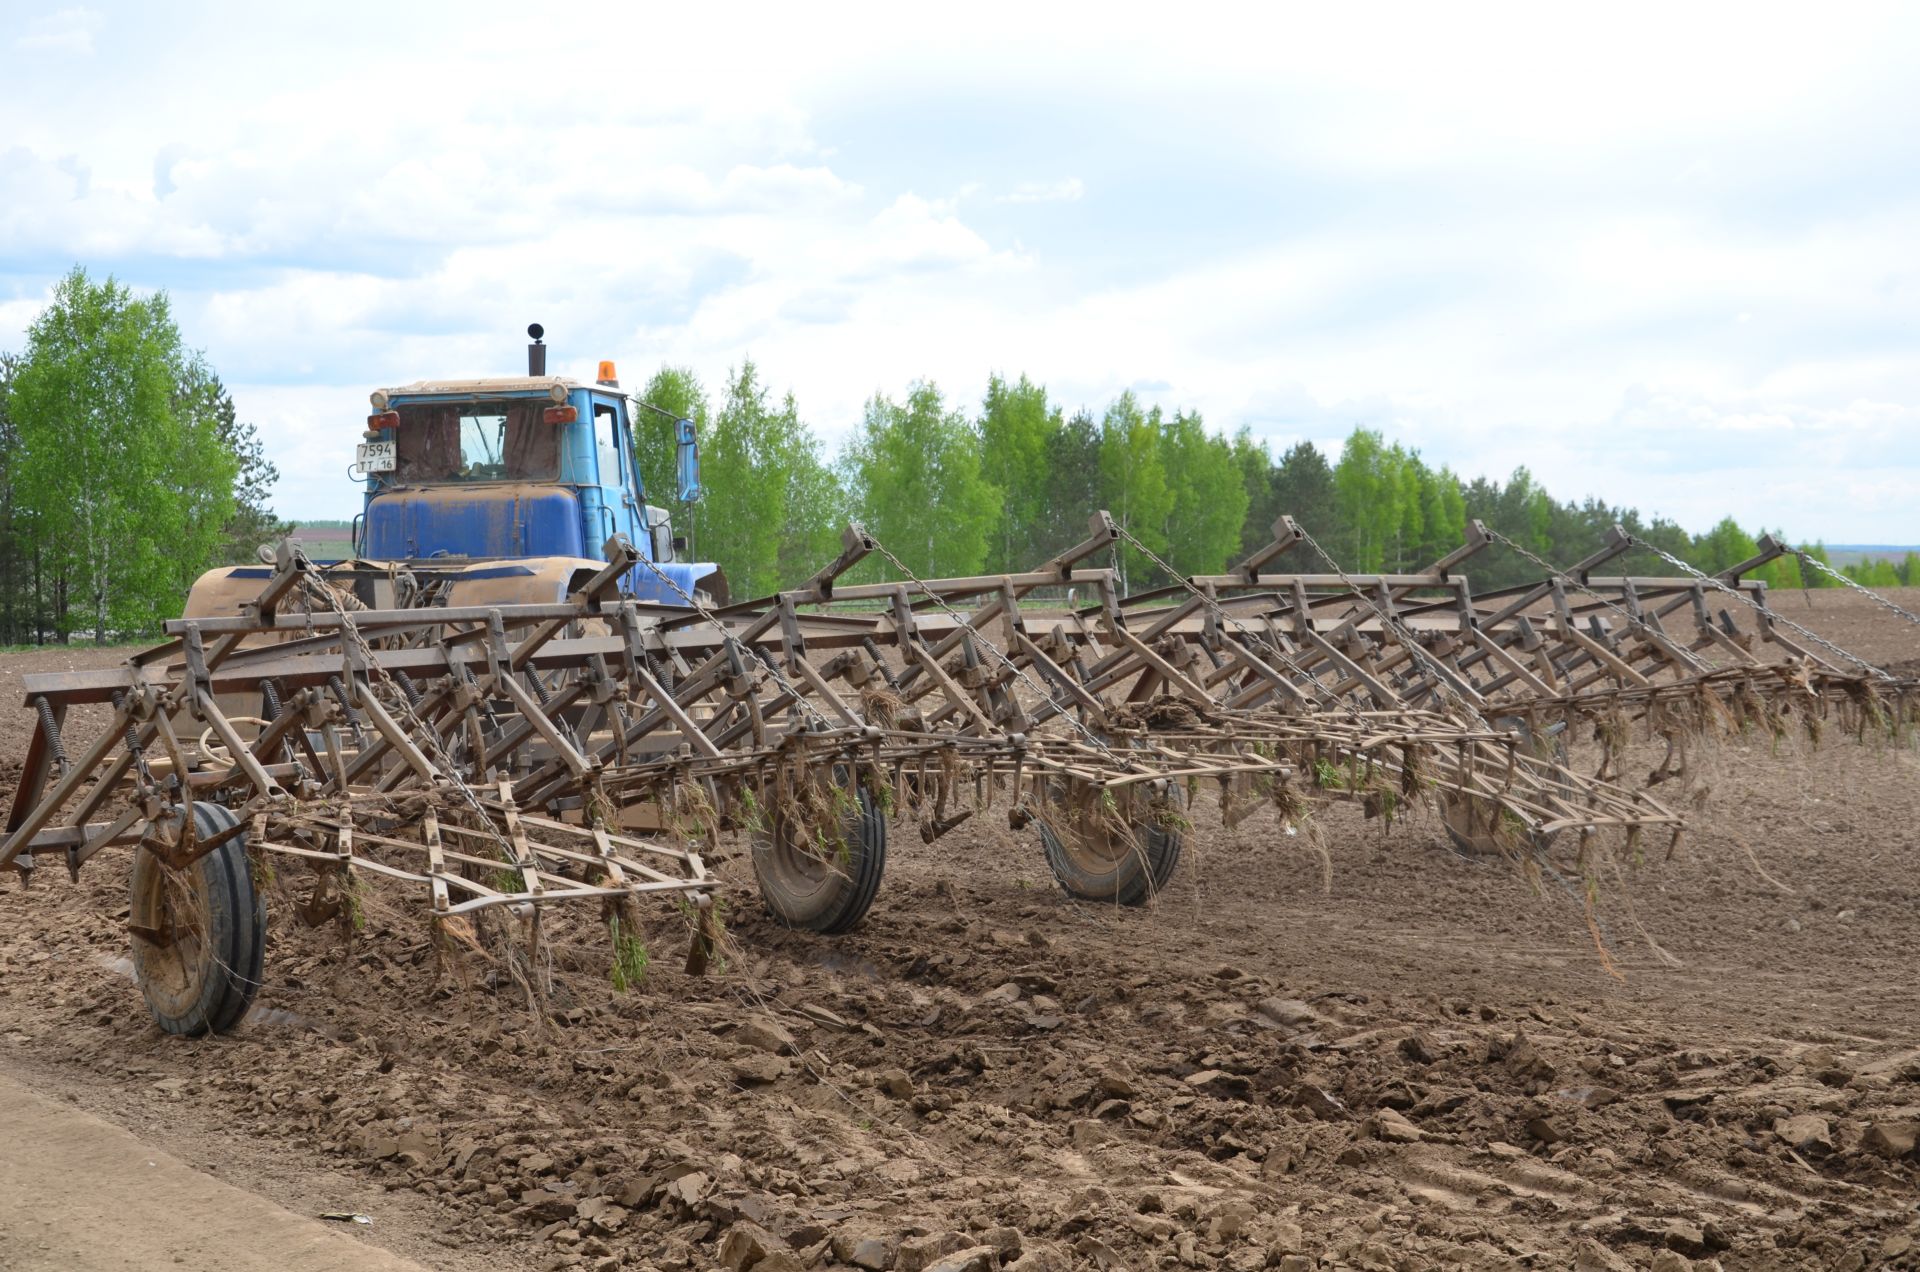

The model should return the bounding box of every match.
[0,267,290,644]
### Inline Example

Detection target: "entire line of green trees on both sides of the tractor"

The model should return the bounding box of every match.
[0,267,1896,644]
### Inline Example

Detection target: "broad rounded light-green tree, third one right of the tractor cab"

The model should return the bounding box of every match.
[843,380,1000,578]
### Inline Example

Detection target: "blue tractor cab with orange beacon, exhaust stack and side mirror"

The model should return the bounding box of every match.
[355,327,726,605]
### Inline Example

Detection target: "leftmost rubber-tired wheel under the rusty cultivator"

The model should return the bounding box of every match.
[131,801,267,1038]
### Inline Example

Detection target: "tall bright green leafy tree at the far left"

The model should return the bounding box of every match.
[8,267,240,642]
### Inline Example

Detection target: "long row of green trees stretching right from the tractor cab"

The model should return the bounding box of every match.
[637,359,1866,596]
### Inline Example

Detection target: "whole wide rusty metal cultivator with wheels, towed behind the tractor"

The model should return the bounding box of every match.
[0,513,1912,1032]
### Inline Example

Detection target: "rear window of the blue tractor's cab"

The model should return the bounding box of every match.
[394,398,561,486]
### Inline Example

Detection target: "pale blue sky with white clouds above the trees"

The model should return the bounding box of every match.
[0,0,1920,544]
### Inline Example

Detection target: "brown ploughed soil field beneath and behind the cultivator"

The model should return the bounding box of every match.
[0,590,1920,1272]
